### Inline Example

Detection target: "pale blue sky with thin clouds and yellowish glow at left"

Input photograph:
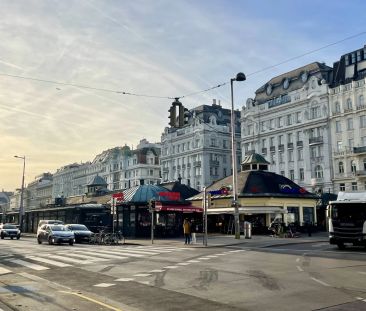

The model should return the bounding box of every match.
[0,0,366,191]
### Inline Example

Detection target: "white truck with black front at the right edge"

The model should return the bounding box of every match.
[327,192,366,249]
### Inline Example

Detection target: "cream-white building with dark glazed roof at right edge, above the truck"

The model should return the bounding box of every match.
[329,46,366,192]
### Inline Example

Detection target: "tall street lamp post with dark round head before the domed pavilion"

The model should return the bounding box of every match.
[230,72,246,239]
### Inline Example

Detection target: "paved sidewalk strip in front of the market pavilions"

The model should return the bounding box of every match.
[22,232,329,248]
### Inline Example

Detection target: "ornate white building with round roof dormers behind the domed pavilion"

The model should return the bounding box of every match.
[241,63,333,192]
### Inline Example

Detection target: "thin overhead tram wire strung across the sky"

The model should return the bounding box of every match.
[0,31,366,99]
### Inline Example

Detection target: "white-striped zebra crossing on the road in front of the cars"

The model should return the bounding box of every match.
[0,246,192,276]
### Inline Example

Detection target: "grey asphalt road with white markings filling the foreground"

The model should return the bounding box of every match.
[0,238,366,311]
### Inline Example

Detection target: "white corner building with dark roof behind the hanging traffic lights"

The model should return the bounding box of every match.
[161,101,240,191]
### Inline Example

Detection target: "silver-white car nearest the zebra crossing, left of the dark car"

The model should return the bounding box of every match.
[37,224,75,245]
